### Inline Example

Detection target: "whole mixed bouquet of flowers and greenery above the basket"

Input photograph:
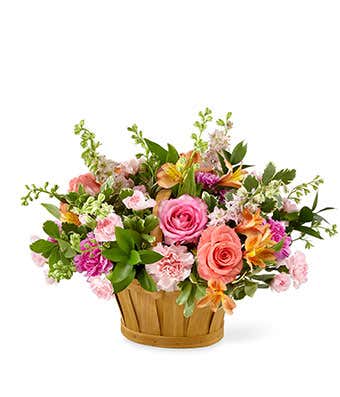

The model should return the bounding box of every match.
[22,108,336,317]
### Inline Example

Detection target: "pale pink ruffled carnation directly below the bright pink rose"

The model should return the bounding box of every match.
[145,243,195,291]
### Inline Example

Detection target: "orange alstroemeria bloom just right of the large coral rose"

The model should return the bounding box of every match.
[243,224,277,269]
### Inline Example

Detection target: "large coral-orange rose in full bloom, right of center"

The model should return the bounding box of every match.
[197,225,242,284]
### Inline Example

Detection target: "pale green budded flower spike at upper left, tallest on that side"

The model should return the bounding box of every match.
[74,120,101,173]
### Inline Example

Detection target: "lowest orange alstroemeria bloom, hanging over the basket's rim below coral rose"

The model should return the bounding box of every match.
[197,279,236,314]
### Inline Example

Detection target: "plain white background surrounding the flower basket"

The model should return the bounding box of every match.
[0,0,340,397]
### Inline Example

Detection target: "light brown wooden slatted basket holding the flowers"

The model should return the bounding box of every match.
[116,280,224,348]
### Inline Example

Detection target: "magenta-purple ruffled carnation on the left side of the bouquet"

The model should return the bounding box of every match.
[74,232,113,277]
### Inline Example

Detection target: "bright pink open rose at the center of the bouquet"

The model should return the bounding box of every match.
[158,194,208,244]
